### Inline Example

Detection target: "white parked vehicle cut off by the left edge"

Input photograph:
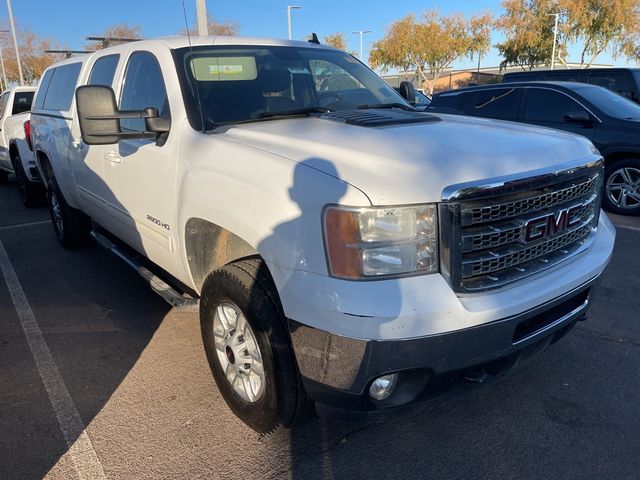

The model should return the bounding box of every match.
[0,87,45,207]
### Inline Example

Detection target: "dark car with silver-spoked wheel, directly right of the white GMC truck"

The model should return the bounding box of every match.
[428,82,640,215]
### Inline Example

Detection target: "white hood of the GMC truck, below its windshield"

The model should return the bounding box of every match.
[224,112,597,205]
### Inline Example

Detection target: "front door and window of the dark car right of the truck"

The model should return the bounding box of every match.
[521,87,597,140]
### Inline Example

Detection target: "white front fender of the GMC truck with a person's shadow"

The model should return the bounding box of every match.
[179,128,370,288]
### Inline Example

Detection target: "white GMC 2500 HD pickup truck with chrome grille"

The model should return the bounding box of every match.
[31,37,615,431]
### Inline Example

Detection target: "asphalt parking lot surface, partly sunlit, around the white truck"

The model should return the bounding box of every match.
[0,178,640,480]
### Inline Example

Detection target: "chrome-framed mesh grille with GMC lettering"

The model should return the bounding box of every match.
[440,157,602,292]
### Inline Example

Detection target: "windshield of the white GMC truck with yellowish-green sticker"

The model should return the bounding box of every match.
[174,46,410,130]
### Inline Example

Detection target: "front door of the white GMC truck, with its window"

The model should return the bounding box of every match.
[104,51,178,270]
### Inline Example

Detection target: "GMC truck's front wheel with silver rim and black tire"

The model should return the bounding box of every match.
[200,259,310,433]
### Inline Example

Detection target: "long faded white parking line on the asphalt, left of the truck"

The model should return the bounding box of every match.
[0,240,106,479]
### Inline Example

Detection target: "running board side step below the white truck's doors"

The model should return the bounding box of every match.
[91,230,200,311]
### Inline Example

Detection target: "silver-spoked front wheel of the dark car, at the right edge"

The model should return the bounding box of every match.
[603,158,640,216]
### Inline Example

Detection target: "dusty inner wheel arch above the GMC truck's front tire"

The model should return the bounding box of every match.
[184,217,260,292]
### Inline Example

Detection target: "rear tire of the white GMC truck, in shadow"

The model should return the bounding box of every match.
[47,177,91,250]
